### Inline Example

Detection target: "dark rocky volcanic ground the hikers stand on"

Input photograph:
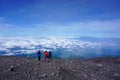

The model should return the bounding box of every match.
[0,56,120,80]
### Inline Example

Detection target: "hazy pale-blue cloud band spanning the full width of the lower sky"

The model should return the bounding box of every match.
[0,19,120,37]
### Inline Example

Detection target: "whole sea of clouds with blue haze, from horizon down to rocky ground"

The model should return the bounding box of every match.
[0,37,120,58]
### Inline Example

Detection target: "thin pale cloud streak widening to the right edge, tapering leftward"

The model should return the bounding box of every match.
[34,19,120,37]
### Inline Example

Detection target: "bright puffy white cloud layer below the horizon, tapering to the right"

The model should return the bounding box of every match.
[0,37,117,54]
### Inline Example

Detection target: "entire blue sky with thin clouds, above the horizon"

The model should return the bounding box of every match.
[0,0,120,38]
